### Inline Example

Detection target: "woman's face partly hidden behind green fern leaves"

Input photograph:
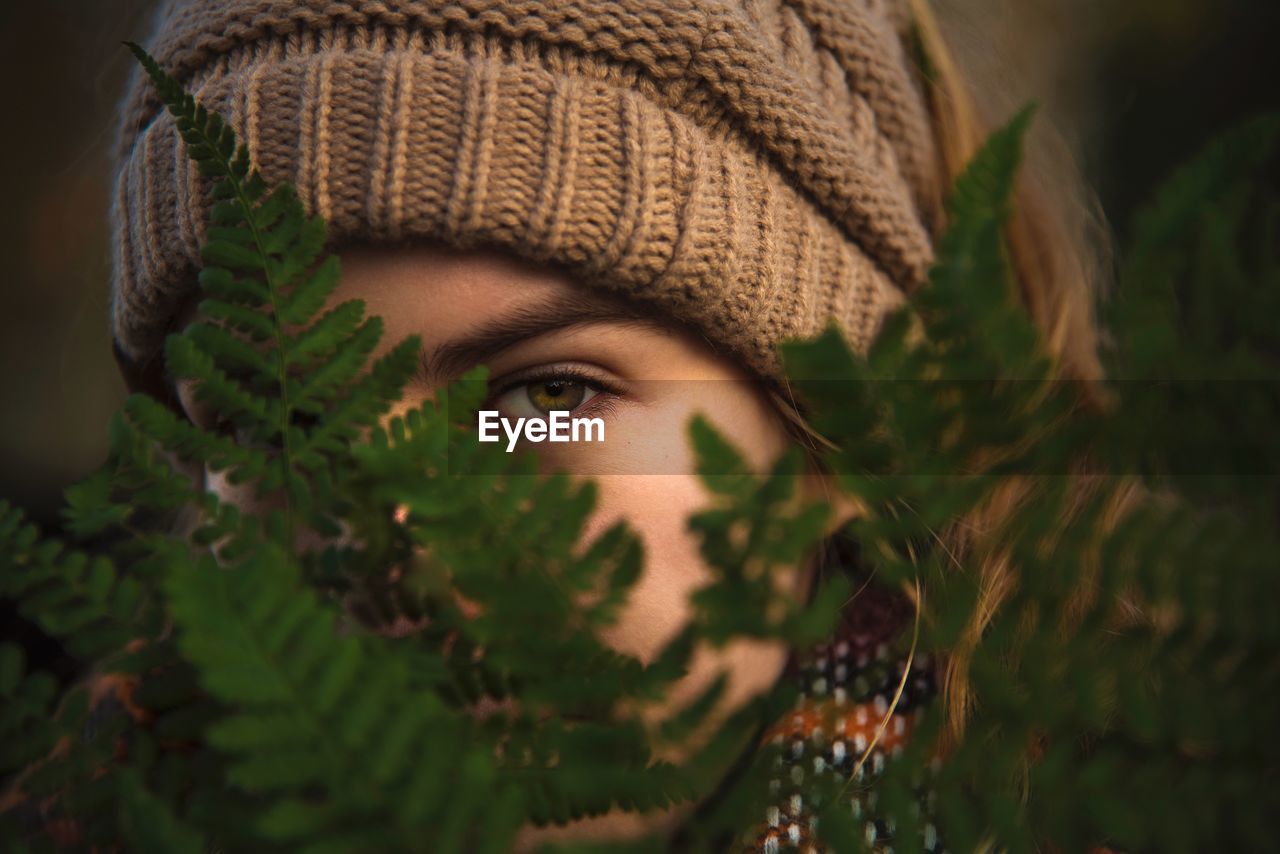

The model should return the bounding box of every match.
[182,246,796,846]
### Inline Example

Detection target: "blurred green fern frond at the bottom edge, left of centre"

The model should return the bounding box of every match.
[166,545,511,850]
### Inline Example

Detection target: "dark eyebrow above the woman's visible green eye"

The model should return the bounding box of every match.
[419,293,666,385]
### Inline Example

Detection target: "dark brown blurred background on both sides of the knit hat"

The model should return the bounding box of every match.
[0,0,1280,530]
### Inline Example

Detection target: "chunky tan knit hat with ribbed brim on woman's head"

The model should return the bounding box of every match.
[111,0,940,383]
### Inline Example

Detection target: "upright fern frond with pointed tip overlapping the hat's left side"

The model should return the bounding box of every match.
[131,45,430,536]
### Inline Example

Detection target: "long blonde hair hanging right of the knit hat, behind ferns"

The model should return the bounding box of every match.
[772,0,1138,746]
